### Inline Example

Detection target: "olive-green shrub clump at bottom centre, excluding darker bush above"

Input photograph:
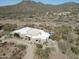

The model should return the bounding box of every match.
[35,48,51,59]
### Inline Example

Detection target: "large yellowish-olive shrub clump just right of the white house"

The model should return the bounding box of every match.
[53,25,72,40]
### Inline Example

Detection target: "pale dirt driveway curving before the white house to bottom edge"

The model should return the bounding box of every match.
[2,39,35,59]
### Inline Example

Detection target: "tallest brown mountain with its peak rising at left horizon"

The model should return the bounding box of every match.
[0,1,46,14]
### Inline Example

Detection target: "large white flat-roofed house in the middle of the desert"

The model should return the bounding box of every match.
[11,27,50,43]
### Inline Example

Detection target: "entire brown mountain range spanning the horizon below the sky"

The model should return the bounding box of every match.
[0,1,79,14]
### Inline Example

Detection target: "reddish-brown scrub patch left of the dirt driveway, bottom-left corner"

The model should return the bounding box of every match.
[0,42,26,59]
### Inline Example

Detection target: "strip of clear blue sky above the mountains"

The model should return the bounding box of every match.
[0,0,79,6]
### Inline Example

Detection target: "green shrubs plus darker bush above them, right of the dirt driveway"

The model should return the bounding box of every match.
[35,44,51,59]
